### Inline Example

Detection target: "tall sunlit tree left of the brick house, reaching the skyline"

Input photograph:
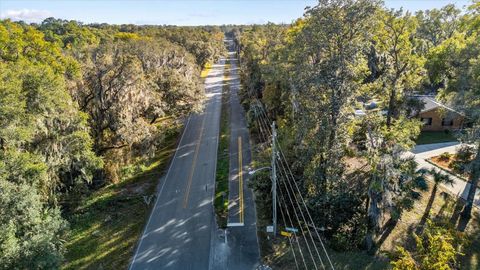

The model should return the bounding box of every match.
[356,10,423,251]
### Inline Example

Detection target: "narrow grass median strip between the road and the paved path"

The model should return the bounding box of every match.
[214,59,230,228]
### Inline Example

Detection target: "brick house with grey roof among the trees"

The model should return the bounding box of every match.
[414,96,465,131]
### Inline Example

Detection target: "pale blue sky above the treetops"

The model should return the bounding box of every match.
[0,0,470,25]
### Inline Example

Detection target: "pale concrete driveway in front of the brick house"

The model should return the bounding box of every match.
[409,142,480,207]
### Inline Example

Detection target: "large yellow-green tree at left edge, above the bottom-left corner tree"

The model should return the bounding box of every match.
[0,21,101,200]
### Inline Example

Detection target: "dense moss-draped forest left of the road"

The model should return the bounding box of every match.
[0,18,225,269]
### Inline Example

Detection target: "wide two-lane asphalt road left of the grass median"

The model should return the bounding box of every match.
[130,59,225,270]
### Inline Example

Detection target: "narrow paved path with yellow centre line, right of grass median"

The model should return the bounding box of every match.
[225,41,260,270]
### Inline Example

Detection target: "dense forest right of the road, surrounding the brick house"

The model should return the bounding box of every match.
[233,0,480,269]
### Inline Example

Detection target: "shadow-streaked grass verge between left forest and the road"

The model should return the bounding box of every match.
[62,126,180,269]
